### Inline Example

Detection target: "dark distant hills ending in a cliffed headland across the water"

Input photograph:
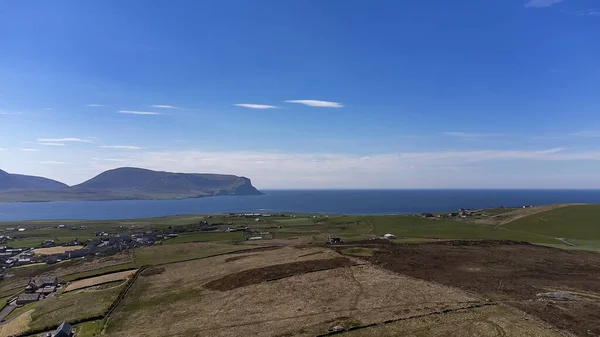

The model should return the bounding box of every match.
[0,167,262,202]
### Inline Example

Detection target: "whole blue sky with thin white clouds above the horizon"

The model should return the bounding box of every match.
[0,0,600,188]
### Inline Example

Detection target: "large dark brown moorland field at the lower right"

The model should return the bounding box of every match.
[342,241,600,336]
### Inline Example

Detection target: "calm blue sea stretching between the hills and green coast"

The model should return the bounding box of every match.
[0,190,600,221]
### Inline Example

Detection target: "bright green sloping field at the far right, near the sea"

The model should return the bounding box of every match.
[502,205,600,240]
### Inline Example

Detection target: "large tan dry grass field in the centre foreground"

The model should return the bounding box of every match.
[107,247,492,337]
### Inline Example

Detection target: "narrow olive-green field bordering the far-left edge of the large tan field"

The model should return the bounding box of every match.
[134,242,256,267]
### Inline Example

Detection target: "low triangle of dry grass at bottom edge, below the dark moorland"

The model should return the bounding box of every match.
[339,305,563,337]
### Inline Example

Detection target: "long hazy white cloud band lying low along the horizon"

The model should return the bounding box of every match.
[75,148,600,188]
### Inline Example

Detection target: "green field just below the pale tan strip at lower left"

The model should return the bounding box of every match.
[29,287,122,330]
